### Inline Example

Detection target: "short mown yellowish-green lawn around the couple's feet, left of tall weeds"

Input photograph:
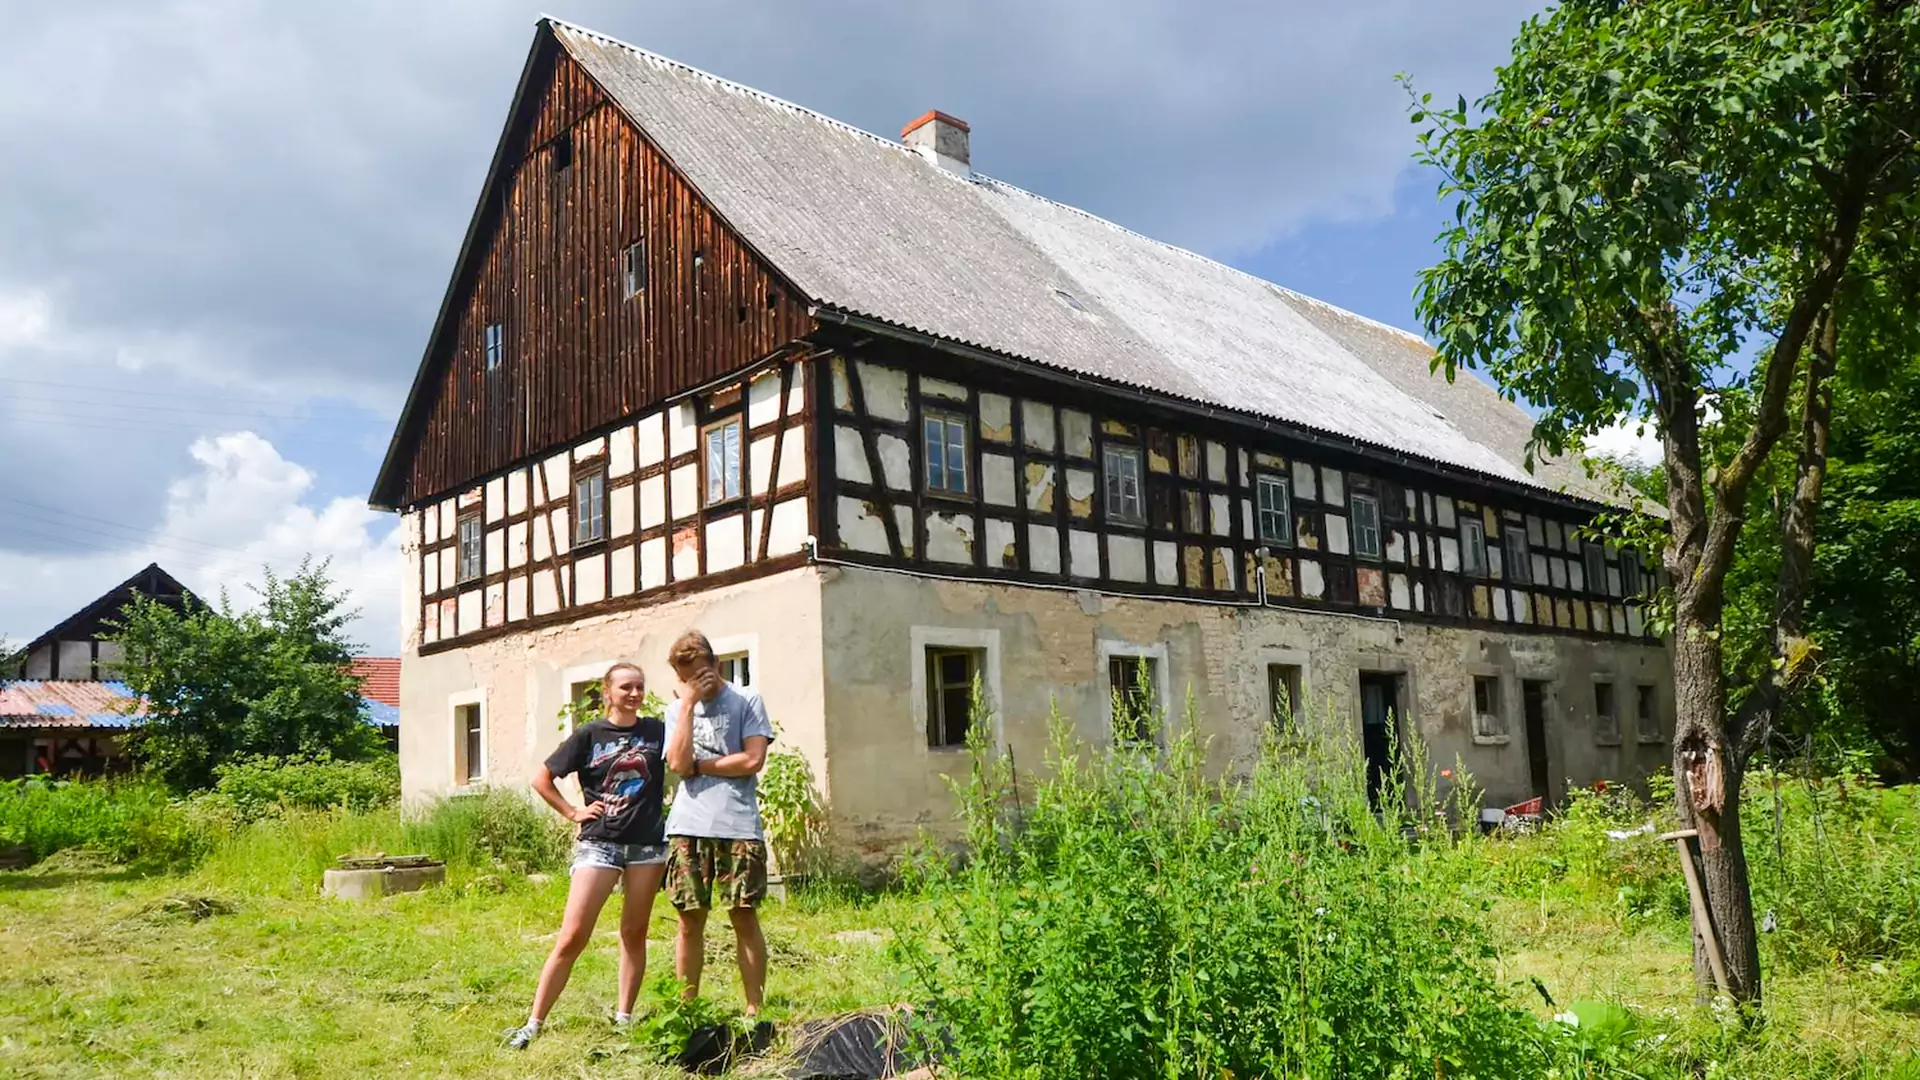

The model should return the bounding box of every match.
[0,867,899,1080]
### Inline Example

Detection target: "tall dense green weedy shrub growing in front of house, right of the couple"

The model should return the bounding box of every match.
[897,691,1557,1078]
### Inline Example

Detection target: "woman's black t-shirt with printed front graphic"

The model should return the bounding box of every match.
[547,717,666,844]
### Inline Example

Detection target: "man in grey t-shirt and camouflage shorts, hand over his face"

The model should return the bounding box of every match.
[666,630,774,1017]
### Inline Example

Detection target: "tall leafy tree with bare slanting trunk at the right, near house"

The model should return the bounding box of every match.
[1413,0,1920,1001]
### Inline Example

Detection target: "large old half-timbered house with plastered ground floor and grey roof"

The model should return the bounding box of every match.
[372,21,1670,844]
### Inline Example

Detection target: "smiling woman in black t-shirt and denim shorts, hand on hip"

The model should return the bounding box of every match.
[507,663,666,1049]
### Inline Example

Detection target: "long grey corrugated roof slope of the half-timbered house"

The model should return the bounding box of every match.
[553,23,1605,498]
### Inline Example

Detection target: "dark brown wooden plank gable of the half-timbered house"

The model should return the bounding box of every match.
[376,40,812,507]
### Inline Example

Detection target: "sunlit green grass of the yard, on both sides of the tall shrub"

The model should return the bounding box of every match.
[0,768,1920,1080]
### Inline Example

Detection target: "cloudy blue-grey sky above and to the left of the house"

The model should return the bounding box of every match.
[0,0,1566,653]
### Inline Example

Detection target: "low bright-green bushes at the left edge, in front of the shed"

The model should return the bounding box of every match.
[0,776,217,869]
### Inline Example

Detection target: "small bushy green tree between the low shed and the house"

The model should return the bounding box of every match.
[115,561,378,792]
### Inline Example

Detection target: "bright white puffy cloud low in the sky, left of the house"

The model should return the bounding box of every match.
[0,430,401,655]
